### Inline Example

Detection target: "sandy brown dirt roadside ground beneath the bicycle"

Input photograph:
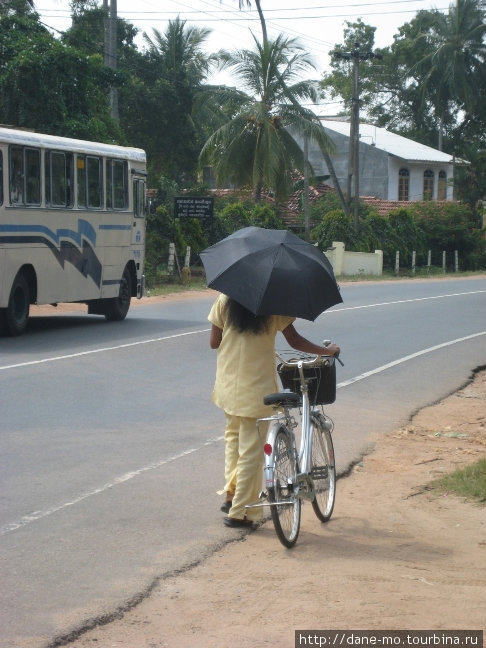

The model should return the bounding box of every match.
[58,360,486,648]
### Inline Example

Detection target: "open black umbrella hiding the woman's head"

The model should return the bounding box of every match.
[197,227,343,321]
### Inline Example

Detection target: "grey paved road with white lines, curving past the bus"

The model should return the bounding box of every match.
[0,279,486,648]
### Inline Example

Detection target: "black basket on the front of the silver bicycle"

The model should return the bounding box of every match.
[277,358,336,405]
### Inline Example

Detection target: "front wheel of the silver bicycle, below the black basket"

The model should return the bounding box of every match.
[311,419,336,522]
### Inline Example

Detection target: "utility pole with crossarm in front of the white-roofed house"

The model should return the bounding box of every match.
[332,42,383,231]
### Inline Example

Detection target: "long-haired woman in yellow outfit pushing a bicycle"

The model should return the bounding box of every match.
[208,295,340,527]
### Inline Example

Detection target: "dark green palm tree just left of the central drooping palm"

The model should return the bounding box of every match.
[120,18,220,185]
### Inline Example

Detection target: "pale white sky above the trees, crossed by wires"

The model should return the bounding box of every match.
[34,0,451,115]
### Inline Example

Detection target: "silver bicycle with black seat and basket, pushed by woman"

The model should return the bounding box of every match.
[248,352,342,549]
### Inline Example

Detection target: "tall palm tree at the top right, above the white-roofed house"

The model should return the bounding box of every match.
[412,0,486,150]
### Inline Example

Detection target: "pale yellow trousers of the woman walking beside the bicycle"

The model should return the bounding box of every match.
[224,414,268,521]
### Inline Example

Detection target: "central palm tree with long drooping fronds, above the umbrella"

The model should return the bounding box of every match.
[200,35,333,201]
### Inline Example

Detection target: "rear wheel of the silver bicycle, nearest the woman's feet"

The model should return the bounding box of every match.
[268,430,301,549]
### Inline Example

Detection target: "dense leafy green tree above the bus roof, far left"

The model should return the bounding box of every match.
[0,2,120,141]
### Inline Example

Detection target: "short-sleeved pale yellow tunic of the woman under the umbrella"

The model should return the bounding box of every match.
[208,295,295,418]
